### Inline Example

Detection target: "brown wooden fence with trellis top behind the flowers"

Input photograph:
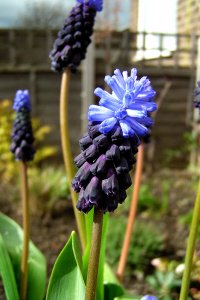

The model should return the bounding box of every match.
[0,29,198,167]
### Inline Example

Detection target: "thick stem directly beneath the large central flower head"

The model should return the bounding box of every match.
[85,210,103,300]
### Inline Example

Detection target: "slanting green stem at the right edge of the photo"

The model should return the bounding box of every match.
[179,179,200,300]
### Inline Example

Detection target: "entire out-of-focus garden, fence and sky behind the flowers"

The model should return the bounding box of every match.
[0,0,200,300]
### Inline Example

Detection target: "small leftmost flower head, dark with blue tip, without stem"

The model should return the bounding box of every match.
[10,90,35,161]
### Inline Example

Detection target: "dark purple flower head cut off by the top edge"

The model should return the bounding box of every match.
[49,0,103,72]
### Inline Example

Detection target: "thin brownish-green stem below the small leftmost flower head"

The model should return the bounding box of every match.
[20,162,30,300]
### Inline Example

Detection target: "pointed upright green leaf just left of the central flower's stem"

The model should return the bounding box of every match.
[46,231,85,300]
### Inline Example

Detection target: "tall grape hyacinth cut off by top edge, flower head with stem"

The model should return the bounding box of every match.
[50,0,102,250]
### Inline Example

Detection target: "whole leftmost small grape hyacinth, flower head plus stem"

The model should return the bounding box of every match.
[10,90,35,300]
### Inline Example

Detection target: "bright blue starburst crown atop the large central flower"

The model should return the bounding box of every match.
[88,68,157,138]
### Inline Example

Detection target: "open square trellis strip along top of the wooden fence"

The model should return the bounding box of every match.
[0,29,199,68]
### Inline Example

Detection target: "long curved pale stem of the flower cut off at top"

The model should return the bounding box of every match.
[60,69,86,250]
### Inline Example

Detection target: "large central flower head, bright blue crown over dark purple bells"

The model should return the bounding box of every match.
[72,69,156,213]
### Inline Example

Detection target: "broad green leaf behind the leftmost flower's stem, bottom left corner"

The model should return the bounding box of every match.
[0,213,46,300]
